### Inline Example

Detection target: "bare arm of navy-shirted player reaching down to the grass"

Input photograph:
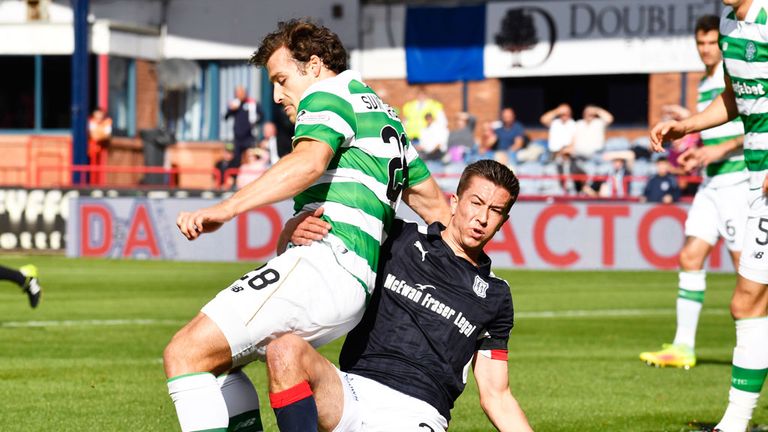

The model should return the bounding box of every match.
[473,354,533,432]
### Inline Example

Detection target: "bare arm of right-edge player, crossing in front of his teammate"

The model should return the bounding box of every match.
[651,75,739,152]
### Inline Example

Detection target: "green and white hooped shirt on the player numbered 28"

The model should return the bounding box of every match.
[293,70,429,293]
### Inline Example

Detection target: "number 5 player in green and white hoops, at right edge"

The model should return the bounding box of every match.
[651,0,768,432]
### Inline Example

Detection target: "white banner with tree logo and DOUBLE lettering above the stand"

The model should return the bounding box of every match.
[484,0,722,77]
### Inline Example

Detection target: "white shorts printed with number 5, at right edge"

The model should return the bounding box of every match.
[739,189,768,284]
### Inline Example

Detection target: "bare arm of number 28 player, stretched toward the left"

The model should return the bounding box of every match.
[176,139,333,240]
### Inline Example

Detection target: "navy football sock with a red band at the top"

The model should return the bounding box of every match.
[269,381,317,432]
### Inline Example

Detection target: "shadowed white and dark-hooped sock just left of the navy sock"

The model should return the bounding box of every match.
[218,369,263,432]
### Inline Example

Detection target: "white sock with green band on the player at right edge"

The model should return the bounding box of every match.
[716,317,768,432]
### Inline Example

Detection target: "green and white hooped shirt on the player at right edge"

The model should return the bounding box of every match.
[720,0,768,189]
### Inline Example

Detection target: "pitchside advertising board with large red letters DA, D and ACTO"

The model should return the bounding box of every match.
[67,198,733,271]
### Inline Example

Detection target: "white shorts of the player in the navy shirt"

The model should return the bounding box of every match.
[333,369,448,432]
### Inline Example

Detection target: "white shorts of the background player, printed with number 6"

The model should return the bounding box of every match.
[685,181,749,252]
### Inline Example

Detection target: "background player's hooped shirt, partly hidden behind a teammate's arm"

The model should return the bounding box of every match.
[696,62,748,187]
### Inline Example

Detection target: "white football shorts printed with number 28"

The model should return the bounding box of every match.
[202,242,366,367]
